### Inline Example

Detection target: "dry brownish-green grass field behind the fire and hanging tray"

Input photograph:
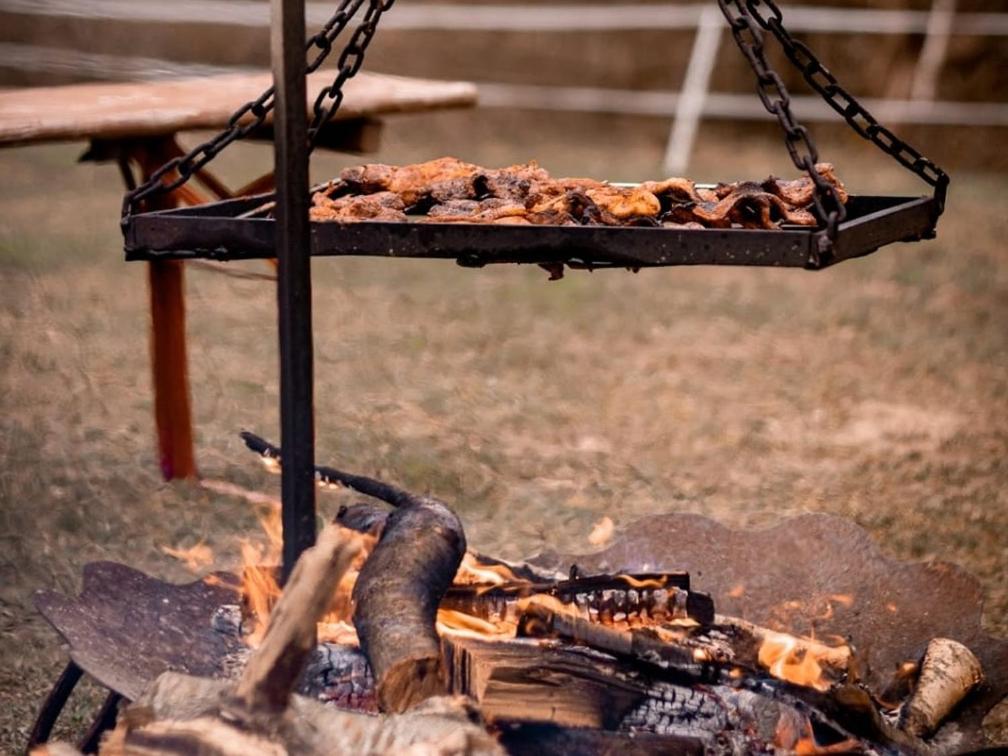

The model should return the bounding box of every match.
[0,107,1008,752]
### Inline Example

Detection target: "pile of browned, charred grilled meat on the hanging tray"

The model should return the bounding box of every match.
[311,157,847,229]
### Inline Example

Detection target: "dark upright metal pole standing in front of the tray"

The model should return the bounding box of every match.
[270,0,316,580]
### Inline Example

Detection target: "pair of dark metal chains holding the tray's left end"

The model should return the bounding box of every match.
[122,0,395,222]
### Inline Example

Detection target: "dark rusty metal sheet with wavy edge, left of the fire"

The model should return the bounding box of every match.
[35,561,241,700]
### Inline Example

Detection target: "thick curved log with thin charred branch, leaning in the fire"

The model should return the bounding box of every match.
[242,432,466,712]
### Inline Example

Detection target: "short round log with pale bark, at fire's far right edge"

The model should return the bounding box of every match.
[899,638,984,738]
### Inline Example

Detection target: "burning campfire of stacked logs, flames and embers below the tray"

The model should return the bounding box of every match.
[33,434,1008,754]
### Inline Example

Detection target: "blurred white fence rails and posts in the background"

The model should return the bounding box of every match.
[0,0,1008,173]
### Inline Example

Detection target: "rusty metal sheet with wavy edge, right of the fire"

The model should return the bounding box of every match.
[530,514,1008,747]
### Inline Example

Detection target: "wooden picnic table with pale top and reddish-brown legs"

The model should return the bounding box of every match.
[0,72,476,480]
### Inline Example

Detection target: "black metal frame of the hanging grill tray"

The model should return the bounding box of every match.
[123,195,937,269]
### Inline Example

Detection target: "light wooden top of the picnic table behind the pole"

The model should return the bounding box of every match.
[0,72,477,145]
